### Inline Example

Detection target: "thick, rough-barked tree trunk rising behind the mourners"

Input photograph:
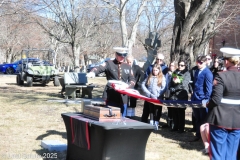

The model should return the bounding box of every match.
[171,0,225,66]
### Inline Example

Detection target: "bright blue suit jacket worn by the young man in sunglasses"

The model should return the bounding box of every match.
[191,67,213,101]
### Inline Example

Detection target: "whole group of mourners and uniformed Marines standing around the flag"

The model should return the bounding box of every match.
[87,46,240,160]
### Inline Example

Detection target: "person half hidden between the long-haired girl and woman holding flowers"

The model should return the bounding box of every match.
[163,61,176,128]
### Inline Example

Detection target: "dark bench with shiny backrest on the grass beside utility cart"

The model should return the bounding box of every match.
[61,72,95,99]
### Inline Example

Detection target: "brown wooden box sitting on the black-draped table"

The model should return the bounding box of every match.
[83,105,121,120]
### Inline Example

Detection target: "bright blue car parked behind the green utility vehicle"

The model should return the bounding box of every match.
[0,58,39,74]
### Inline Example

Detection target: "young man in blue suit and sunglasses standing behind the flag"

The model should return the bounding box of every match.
[191,56,213,141]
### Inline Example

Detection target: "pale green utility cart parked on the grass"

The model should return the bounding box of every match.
[16,49,60,87]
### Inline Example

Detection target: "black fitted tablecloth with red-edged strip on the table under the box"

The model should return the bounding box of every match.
[62,113,154,160]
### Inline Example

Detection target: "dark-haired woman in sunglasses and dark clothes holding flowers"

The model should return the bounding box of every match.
[169,60,191,133]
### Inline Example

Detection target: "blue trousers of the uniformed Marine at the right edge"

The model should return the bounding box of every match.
[210,125,240,160]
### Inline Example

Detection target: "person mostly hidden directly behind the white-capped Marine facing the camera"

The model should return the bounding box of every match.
[126,55,144,117]
